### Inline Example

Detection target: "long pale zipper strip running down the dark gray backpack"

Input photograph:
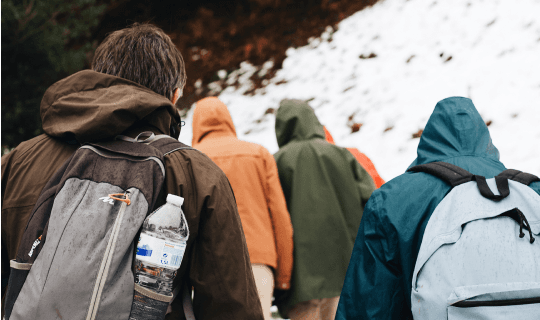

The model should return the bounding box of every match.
[86,192,128,320]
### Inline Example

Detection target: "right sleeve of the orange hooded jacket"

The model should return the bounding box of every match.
[264,149,293,290]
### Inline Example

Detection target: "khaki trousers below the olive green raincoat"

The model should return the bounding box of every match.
[288,297,339,320]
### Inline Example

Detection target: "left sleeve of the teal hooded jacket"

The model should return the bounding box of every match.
[336,192,411,320]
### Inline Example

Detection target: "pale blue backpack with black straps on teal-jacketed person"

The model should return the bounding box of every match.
[409,162,540,320]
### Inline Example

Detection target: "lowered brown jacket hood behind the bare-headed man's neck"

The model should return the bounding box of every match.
[40,70,180,143]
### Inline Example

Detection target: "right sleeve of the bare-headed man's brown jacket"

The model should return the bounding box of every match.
[166,151,264,320]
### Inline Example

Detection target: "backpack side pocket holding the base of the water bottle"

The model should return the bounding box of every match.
[129,284,173,320]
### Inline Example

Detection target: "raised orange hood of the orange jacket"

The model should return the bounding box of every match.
[192,97,236,146]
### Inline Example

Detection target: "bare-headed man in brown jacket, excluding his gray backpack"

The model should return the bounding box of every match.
[1,23,263,320]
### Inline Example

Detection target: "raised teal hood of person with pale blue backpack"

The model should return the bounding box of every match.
[411,97,499,166]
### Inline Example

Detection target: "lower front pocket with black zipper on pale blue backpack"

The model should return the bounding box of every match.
[448,282,540,320]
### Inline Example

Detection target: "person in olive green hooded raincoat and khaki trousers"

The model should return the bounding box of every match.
[274,99,375,320]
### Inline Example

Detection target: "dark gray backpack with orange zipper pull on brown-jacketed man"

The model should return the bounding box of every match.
[5,132,196,320]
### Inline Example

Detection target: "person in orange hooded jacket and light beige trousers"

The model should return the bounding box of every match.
[192,97,293,320]
